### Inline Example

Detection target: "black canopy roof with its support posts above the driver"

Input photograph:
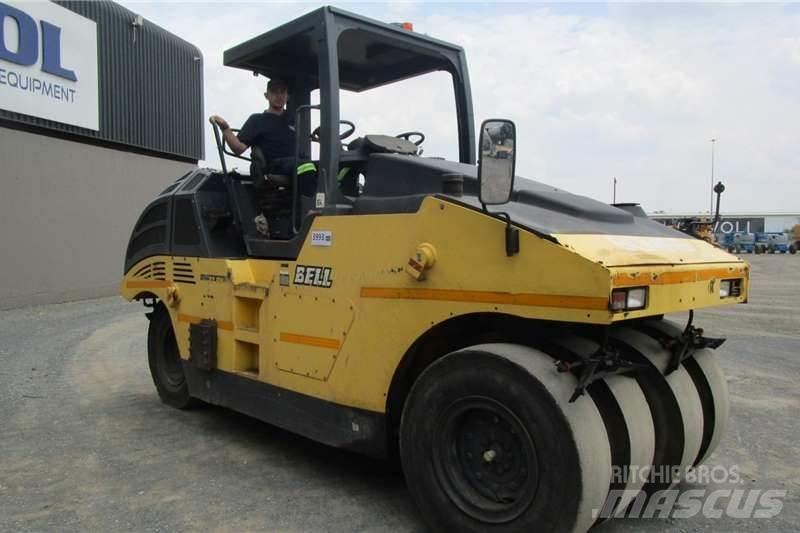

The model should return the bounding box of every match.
[223,6,475,206]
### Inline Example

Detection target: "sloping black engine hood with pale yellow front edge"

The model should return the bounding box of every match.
[373,154,738,267]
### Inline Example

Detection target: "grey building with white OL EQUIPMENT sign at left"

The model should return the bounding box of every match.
[0,0,203,309]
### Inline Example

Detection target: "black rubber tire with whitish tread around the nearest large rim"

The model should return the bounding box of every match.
[400,344,611,533]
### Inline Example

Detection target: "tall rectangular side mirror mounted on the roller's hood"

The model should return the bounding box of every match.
[478,119,517,205]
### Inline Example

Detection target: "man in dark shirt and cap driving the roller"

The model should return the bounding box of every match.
[211,78,317,196]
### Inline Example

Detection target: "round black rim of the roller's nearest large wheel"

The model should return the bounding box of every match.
[433,396,539,524]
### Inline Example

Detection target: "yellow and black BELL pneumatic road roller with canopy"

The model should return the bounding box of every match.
[120,7,749,532]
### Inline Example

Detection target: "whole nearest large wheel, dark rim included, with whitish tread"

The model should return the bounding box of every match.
[400,344,611,533]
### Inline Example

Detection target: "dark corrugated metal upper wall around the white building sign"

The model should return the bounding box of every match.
[0,1,204,161]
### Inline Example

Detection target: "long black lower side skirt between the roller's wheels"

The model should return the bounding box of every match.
[183,361,386,458]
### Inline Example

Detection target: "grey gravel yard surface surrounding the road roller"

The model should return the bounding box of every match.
[0,256,800,533]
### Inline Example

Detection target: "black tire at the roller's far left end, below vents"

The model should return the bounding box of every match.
[147,303,199,409]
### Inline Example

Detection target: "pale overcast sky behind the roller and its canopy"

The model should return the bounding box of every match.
[122,2,800,213]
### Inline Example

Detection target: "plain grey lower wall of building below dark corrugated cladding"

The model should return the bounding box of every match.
[0,127,195,309]
